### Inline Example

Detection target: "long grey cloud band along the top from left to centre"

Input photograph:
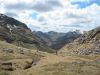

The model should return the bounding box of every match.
[2,0,61,12]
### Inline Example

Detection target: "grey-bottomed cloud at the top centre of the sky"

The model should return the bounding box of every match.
[33,0,61,12]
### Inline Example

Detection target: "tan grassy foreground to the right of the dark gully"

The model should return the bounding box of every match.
[12,54,100,75]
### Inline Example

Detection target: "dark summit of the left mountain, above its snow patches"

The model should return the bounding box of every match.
[0,14,29,29]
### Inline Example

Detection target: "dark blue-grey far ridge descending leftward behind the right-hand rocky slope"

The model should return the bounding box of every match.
[52,31,81,49]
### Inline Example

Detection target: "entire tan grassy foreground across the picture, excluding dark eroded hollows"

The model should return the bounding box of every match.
[0,41,100,75]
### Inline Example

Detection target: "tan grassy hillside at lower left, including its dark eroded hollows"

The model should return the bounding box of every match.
[0,41,43,75]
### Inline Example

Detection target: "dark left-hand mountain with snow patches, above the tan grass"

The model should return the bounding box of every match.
[0,14,52,52]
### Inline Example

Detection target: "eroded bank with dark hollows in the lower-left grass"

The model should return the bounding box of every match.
[0,59,36,71]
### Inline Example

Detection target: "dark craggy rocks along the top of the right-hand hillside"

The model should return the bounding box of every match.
[77,27,100,44]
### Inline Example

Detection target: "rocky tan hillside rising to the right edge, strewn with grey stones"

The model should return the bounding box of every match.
[60,27,100,55]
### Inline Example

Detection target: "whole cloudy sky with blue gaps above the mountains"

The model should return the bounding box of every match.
[0,0,100,32]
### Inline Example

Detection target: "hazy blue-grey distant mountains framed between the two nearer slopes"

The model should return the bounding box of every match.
[33,31,81,50]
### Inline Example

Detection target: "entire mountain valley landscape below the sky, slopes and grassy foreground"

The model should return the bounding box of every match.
[0,14,100,75]
